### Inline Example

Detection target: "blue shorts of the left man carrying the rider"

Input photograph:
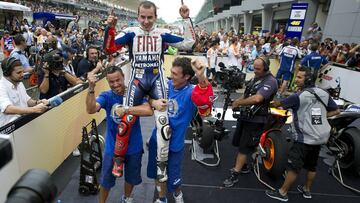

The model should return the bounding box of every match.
[100,151,143,190]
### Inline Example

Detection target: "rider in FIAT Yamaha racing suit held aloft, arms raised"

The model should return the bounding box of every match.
[104,1,195,182]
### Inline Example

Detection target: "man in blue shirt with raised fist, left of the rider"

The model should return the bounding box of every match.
[86,66,153,203]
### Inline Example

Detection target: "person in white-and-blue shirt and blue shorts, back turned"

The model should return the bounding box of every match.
[276,38,301,94]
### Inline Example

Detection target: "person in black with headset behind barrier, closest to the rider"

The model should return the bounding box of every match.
[76,46,103,78]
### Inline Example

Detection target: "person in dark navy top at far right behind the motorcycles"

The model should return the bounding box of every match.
[300,43,328,76]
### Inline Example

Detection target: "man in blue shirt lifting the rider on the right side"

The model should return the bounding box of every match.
[147,57,213,203]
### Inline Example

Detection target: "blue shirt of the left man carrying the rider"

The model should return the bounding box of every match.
[96,90,143,156]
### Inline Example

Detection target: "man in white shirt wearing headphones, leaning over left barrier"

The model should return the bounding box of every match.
[0,57,48,127]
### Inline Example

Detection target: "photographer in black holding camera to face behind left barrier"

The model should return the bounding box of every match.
[38,51,82,99]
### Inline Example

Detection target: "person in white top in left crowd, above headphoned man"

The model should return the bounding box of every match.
[10,34,34,72]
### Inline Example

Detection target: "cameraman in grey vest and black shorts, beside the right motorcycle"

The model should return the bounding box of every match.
[266,67,340,201]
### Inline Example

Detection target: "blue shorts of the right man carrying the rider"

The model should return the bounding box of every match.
[147,136,184,193]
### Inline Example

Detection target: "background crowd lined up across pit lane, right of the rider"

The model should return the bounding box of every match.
[195,23,360,68]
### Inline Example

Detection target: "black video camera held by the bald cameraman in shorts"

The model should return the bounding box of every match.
[215,62,246,90]
